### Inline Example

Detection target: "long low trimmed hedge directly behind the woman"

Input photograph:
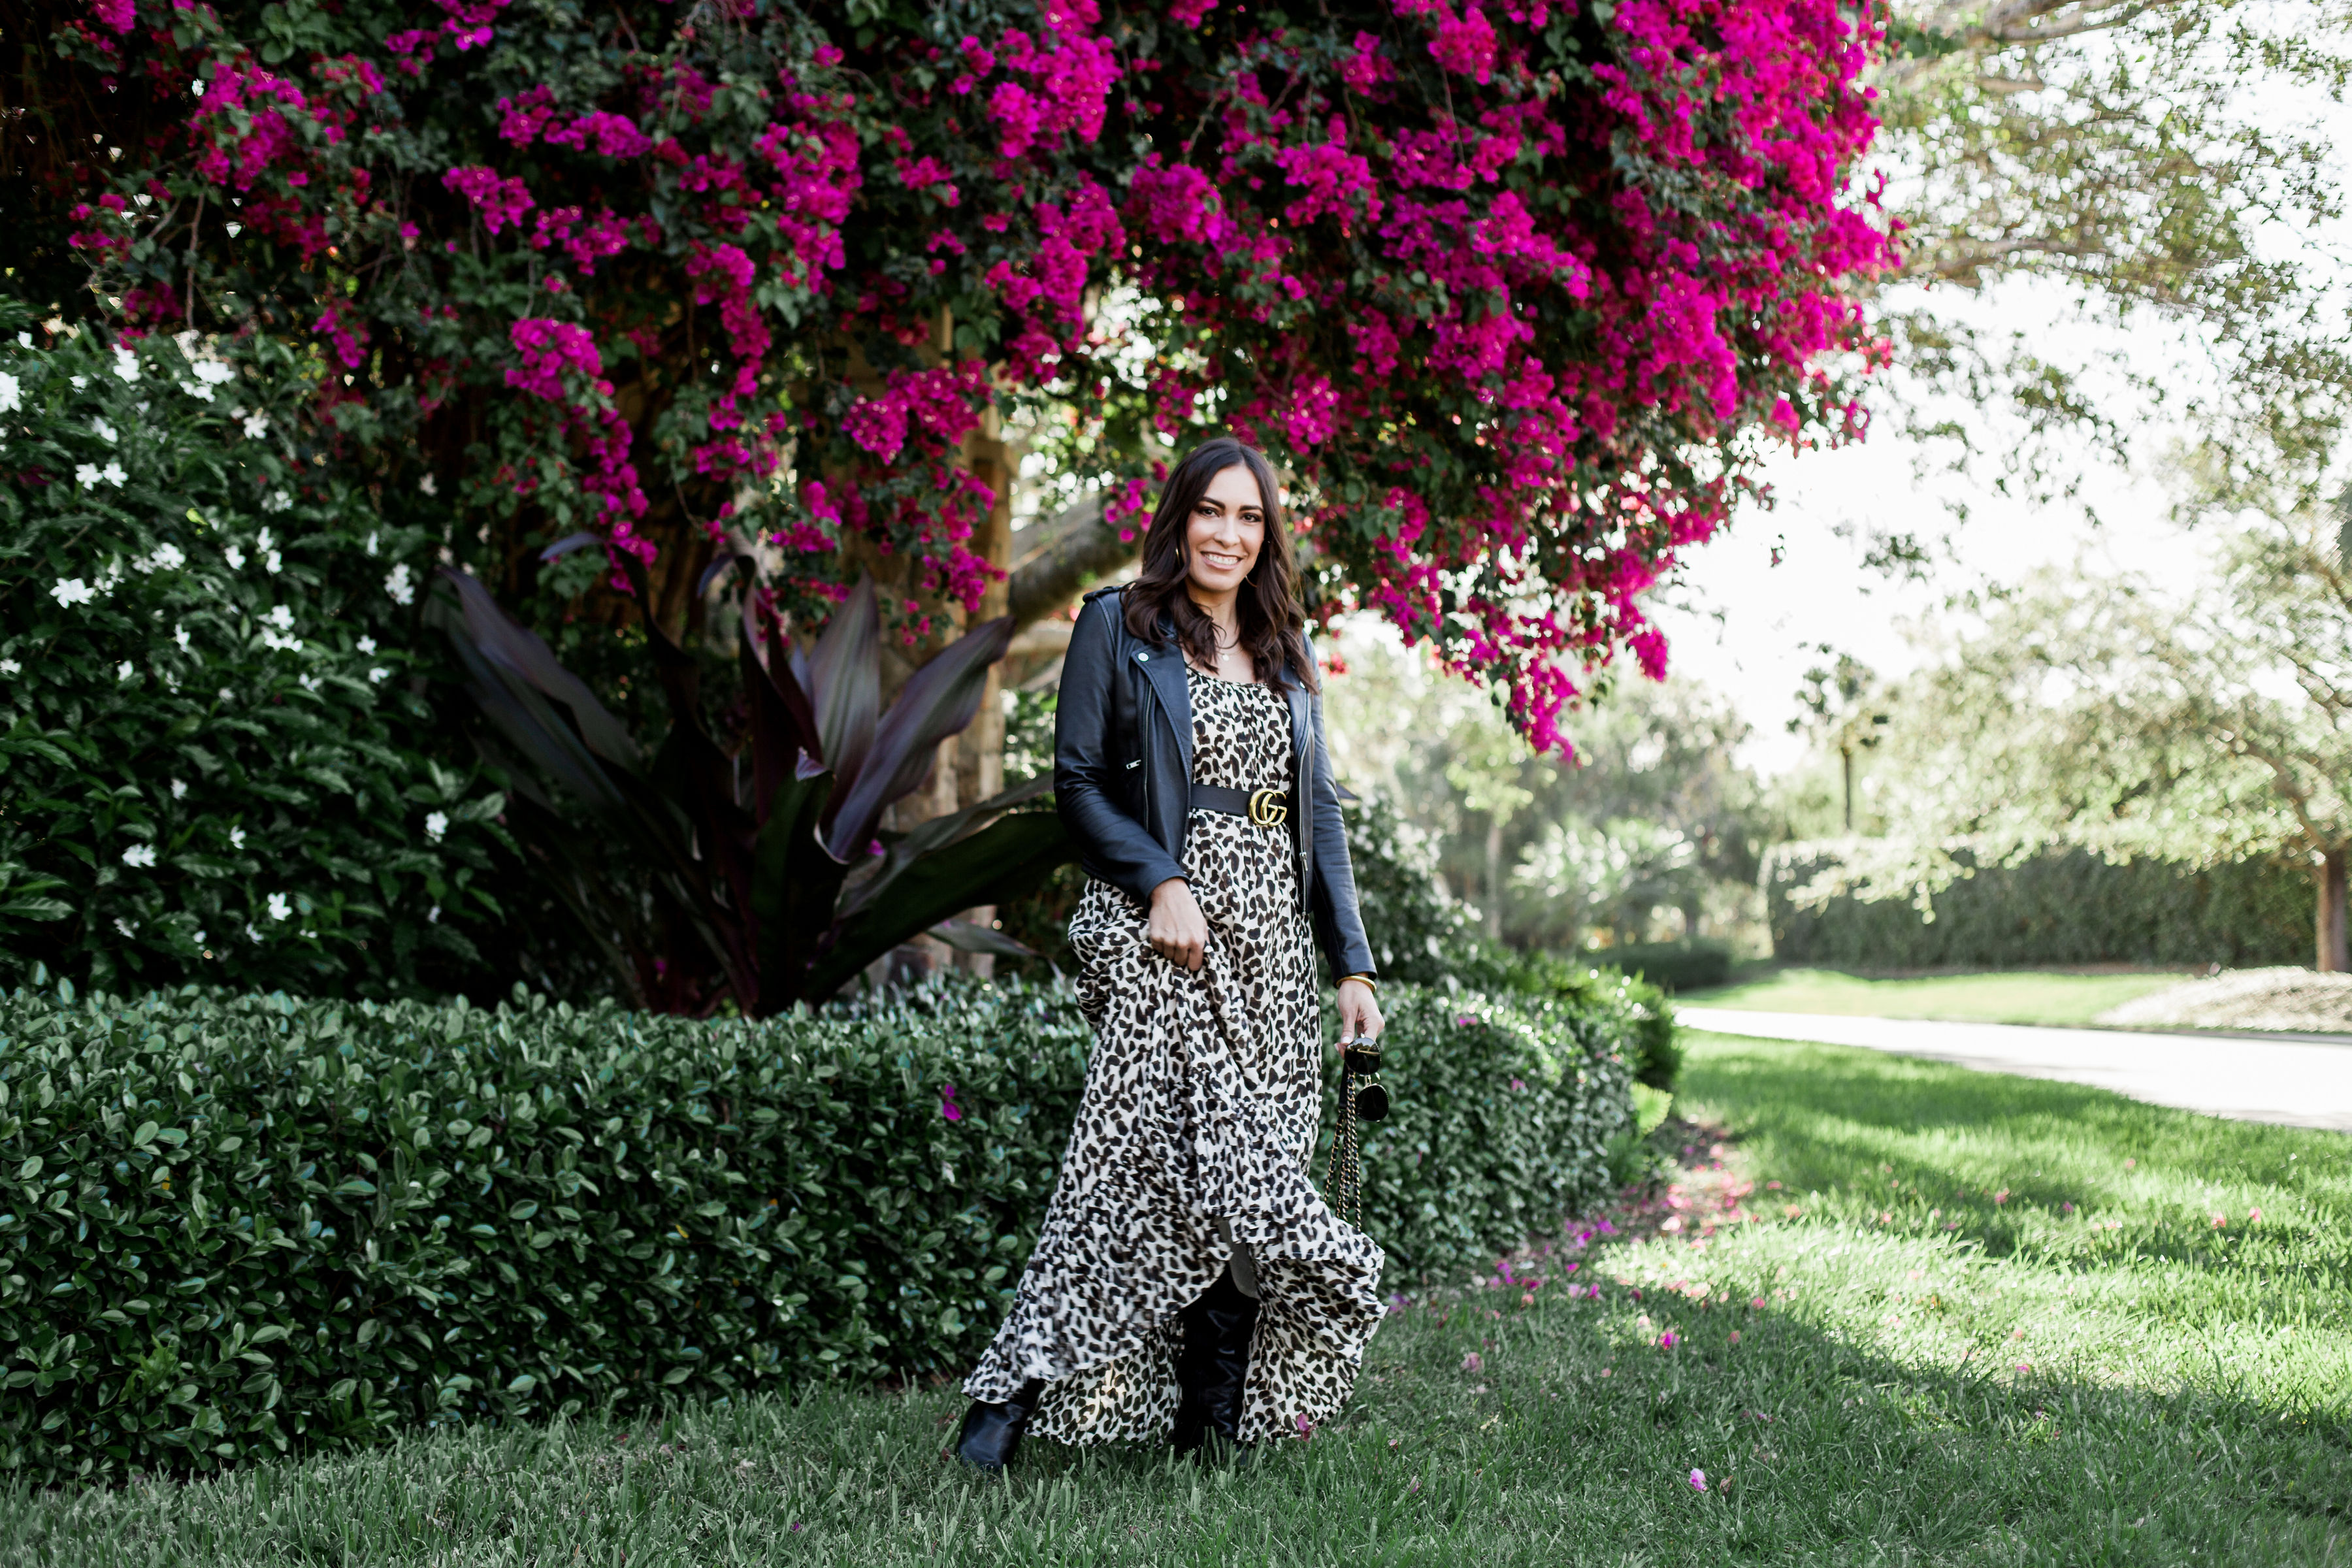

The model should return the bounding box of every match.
[0,983,1656,1481]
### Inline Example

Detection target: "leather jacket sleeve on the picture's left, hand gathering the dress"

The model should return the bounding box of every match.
[1054,595,1185,903]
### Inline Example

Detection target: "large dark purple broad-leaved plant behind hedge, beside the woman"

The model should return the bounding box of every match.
[435,545,1073,1018]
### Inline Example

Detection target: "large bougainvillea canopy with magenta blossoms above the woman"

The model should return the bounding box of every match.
[12,0,1889,743]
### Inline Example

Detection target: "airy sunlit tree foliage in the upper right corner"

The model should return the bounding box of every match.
[1872,0,2352,517]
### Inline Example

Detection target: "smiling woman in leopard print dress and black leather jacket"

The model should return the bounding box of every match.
[957,437,1383,1469]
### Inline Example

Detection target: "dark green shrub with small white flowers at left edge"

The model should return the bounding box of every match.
[0,299,501,994]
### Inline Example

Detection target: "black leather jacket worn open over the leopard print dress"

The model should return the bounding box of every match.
[1054,588,1373,978]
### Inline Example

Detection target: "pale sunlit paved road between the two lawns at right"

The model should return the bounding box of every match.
[1674,1006,2352,1133]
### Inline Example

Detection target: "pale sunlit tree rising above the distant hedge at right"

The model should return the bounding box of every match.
[1839,489,2352,971]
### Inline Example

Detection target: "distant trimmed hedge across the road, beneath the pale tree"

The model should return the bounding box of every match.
[1761,844,2312,968]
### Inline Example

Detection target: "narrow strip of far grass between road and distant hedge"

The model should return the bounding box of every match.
[1677,968,2187,1022]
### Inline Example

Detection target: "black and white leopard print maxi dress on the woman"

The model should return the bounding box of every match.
[964,670,1383,1443]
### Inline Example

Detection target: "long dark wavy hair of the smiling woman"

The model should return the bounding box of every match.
[1122,435,1317,691]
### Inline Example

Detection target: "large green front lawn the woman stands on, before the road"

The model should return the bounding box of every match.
[0,1034,2352,1568]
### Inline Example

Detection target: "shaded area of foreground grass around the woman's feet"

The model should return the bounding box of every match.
[18,1250,2352,1568]
